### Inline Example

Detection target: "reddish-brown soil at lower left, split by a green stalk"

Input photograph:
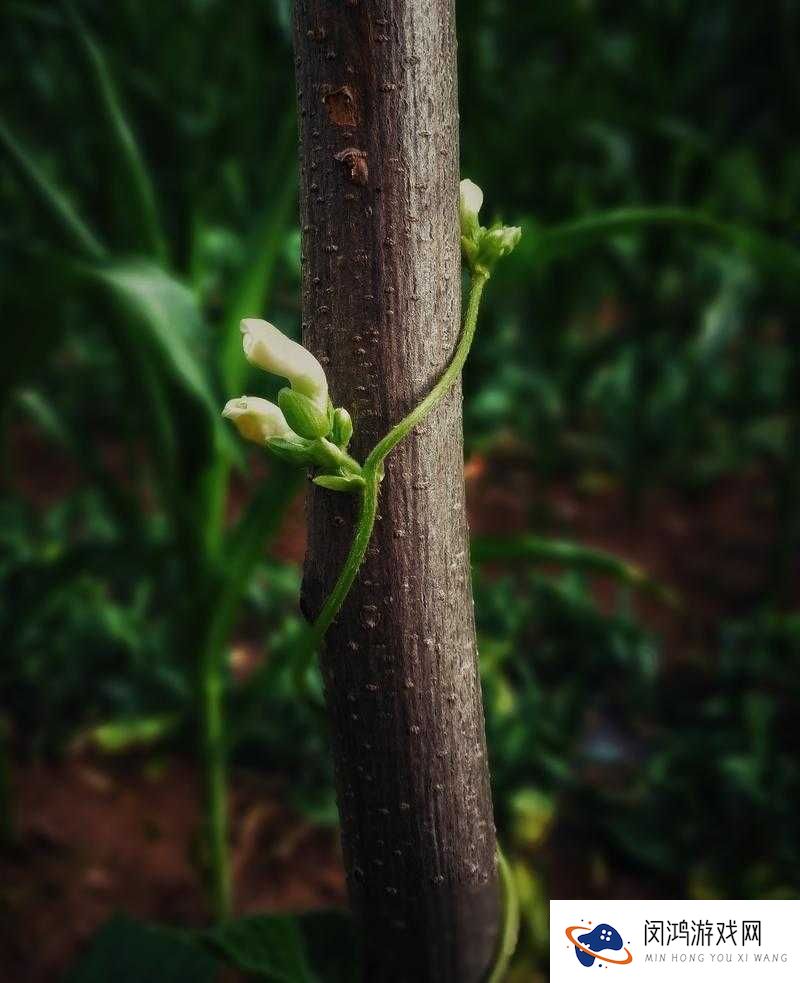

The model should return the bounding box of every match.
[0,756,344,983]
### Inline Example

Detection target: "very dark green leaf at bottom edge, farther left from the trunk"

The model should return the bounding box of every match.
[66,915,218,983]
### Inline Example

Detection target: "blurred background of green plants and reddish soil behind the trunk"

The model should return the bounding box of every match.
[0,0,800,980]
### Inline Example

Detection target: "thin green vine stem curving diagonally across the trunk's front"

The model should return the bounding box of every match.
[298,270,489,660]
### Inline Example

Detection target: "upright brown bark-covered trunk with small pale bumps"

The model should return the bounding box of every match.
[295,0,498,983]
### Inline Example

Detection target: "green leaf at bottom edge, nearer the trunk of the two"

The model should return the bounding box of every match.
[203,915,317,983]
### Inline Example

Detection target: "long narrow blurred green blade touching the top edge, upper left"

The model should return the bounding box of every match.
[64,2,167,263]
